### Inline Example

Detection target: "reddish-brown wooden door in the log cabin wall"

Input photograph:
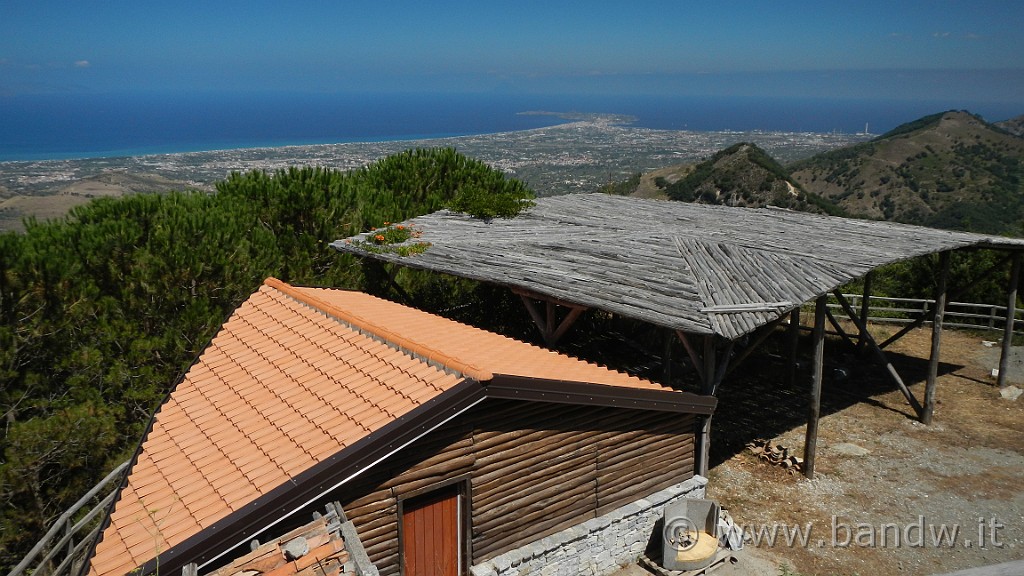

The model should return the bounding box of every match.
[401,486,462,576]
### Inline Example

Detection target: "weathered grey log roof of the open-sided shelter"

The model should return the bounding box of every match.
[332,194,1024,339]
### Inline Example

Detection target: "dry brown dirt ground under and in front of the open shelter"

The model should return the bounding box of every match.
[709,326,1024,575]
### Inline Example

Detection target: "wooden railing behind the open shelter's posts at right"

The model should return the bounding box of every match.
[828,294,1024,332]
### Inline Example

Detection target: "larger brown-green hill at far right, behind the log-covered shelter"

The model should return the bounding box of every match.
[788,111,1024,234]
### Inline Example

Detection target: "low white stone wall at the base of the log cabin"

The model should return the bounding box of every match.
[470,476,708,576]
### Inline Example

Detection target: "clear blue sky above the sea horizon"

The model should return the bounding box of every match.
[0,0,1024,103]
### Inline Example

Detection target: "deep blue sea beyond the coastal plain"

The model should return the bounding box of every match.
[0,93,1024,161]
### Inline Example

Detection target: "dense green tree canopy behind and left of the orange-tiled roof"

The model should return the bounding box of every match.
[0,149,532,571]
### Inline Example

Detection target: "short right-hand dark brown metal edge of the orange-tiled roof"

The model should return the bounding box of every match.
[484,374,718,415]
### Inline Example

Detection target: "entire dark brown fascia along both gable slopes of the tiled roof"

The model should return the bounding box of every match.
[130,374,718,575]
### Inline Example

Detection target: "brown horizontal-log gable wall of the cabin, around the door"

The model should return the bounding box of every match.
[332,400,696,575]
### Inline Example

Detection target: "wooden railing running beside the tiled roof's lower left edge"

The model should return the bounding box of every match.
[7,462,128,576]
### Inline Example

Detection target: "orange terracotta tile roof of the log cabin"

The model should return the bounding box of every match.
[90,279,714,576]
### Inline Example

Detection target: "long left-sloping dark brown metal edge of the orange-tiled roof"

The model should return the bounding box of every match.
[129,378,485,576]
